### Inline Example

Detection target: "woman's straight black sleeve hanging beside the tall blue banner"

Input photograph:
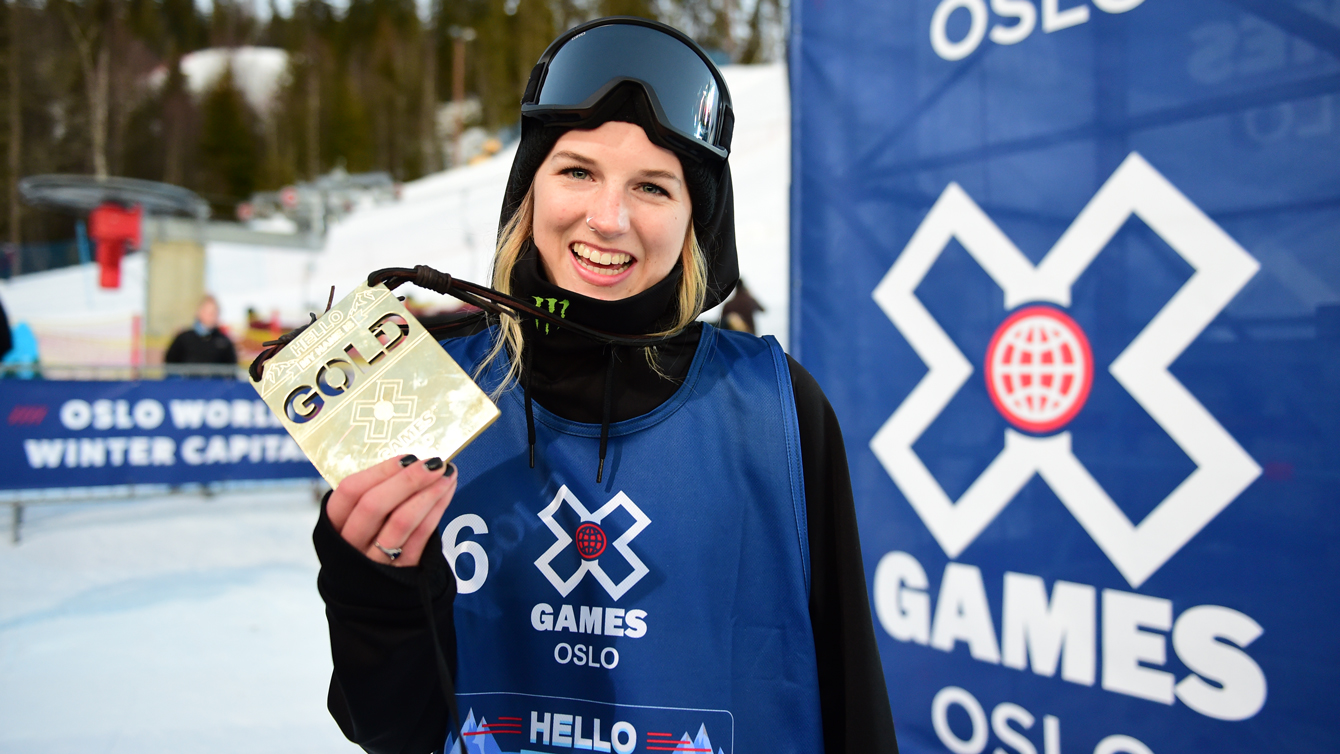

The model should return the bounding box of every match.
[787,356,898,754]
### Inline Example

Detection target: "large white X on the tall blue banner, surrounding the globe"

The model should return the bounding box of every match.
[870,153,1261,587]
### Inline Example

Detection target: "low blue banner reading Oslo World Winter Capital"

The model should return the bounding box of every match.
[0,379,318,489]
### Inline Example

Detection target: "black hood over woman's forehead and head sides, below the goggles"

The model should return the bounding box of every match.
[498,84,740,321]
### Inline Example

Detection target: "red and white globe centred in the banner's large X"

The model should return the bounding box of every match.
[986,307,1093,433]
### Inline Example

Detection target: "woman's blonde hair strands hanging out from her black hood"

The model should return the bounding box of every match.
[474,183,708,399]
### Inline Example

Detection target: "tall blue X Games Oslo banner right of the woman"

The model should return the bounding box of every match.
[789,0,1340,754]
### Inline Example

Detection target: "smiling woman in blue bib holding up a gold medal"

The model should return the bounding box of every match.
[315,19,896,753]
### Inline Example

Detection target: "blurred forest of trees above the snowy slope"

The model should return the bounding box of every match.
[0,0,787,250]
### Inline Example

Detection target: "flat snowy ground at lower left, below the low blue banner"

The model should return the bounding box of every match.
[0,487,358,754]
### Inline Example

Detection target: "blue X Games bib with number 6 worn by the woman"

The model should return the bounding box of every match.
[442,325,823,754]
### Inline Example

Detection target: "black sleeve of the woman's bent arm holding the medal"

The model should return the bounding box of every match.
[312,495,456,754]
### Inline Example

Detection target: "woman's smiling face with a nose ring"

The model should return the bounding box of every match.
[532,121,693,301]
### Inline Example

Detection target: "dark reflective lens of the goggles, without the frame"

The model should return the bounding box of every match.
[535,24,721,149]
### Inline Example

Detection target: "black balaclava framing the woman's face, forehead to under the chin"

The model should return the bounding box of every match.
[498,83,740,335]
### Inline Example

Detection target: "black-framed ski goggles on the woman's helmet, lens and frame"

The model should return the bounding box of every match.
[521,16,734,159]
